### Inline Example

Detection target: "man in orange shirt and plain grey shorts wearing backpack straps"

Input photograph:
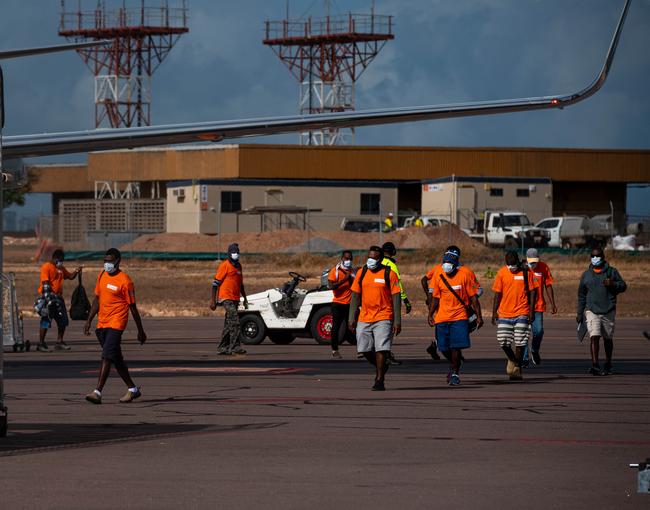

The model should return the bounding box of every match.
[348,246,402,391]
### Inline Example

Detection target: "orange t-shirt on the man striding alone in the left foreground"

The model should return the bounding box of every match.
[95,271,135,331]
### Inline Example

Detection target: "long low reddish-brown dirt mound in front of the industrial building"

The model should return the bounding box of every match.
[121,226,486,255]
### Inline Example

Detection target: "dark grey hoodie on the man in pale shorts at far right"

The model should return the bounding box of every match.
[578,262,627,317]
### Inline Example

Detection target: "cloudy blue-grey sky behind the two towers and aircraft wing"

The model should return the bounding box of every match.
[0,0,650,216]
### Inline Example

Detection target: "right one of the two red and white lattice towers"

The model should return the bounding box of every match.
[263,3,395,145]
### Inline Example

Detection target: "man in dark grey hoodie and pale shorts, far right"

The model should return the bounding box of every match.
[576,247,627,375]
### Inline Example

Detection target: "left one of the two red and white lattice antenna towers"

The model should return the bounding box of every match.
[59,0,189,128]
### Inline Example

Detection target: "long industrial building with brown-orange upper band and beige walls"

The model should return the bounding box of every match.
[29,144,650,245]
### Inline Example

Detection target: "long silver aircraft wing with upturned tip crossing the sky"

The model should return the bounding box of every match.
[2,0,631,158]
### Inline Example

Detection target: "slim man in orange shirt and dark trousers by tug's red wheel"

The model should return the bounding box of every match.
[327,250,356,359]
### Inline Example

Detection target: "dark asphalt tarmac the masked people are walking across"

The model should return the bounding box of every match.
[0,318,650,510]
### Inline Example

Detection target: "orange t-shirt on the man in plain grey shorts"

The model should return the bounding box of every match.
[352,266,401,322]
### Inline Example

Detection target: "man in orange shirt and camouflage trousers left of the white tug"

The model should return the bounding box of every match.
[210,243,248,356]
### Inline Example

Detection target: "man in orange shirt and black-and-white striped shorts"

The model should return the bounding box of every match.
[492,251,539,380]
